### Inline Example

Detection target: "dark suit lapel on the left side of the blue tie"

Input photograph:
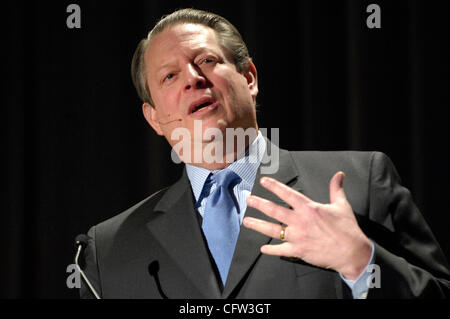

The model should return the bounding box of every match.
[147,171,221,298]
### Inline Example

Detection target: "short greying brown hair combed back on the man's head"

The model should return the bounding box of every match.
[131,9,251,106]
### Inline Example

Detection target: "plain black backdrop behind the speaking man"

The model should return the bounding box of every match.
[0,0,450,298]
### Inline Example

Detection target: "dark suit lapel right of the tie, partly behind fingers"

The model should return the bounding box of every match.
[222,146,301,298]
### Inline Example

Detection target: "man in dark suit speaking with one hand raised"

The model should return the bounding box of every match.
[81,9,450,298]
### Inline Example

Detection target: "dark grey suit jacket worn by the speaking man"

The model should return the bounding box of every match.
[80,150,450,298]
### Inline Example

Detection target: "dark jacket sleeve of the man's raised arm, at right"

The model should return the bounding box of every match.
[368,152,450,298]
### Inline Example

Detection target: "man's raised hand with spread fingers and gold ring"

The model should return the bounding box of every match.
[243,172,371,280]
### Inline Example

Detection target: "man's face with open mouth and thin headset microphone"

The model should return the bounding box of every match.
[143,24,258,154]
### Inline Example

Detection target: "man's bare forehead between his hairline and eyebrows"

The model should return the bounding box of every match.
[145,24,221,65]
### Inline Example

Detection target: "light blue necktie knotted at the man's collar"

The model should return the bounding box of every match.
[202,169,241,286]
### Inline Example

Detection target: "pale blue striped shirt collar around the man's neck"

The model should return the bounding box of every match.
[186,131,266,201]
